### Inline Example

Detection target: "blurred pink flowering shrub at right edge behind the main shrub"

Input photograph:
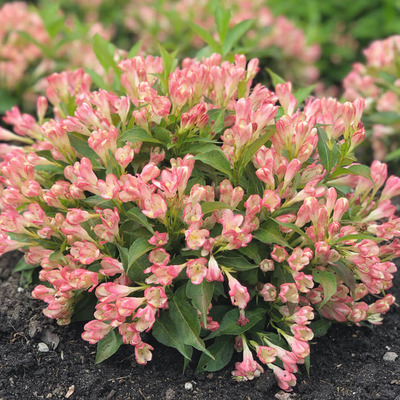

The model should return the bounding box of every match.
[343,36,400,160]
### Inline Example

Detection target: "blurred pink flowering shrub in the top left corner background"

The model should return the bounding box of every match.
[0,2,111,112]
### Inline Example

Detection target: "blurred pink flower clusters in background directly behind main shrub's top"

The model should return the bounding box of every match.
[125,0,320,85]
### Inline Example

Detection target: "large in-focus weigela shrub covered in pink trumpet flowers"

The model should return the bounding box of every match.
[0,54,400,390]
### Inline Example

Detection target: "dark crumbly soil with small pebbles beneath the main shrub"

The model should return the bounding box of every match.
[0,253,400,400]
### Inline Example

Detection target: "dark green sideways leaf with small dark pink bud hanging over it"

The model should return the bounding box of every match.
[206,308,266,340]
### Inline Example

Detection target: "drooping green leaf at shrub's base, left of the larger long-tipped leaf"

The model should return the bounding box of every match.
[151,311,191,360]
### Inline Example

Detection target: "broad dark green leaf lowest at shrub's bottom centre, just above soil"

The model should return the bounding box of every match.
[196,336,235,372]
